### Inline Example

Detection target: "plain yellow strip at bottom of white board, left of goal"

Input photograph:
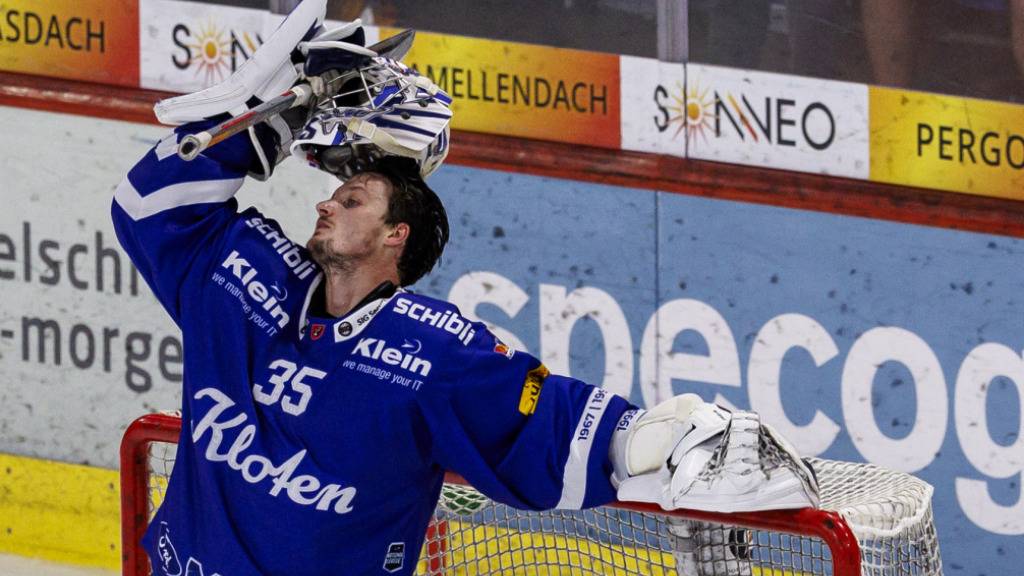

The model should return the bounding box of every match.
[0,454,121,570]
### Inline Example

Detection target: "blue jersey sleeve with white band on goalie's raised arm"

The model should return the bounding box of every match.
[111,125,255,325]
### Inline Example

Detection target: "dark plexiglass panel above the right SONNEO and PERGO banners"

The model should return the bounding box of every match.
[688,0,1024,101]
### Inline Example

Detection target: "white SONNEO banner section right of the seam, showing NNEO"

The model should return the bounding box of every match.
[685,64,868,178]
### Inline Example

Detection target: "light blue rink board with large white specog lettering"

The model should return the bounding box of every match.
[419,166,1024,575]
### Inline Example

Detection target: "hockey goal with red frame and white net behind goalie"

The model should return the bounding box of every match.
[121,414,942,576]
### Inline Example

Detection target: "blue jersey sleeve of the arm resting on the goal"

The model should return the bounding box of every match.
[415,324,634,509]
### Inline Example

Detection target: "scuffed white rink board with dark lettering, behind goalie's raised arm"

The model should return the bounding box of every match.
[0,107,333,468]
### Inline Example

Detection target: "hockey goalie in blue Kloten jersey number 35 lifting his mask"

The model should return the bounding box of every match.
[112,0,817,576]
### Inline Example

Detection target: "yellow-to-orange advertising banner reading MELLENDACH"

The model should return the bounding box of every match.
[381,28,622,149]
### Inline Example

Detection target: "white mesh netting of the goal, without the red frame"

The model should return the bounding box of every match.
[140,436,942,576]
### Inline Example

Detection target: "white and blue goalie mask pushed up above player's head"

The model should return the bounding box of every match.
[291,56,452,180]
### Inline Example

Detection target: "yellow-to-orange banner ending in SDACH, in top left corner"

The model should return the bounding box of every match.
[0,0,139,86]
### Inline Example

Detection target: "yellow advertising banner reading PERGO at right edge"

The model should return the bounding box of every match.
[870,86,1024,200]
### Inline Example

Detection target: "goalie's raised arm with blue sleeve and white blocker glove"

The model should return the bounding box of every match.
[112,0,387,321]
